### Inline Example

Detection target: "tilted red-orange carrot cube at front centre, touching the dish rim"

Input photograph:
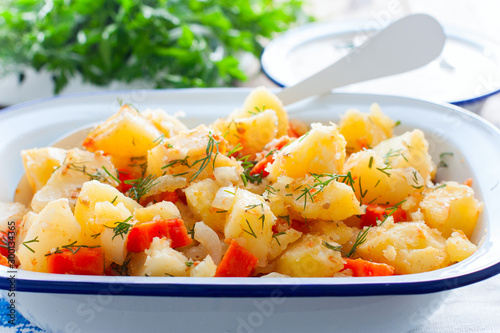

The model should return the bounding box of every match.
[215,239,258,277]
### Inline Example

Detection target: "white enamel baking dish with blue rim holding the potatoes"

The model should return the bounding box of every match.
[0,89,500,332]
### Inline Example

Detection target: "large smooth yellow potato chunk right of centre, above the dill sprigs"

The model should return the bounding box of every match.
[267,124,346,182]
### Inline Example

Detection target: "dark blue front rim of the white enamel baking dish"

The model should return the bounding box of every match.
[0,263,500,298]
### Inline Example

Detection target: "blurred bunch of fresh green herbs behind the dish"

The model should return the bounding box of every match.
[0,0,311,94]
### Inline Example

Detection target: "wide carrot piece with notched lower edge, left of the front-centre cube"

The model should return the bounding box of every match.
[127,219,193,252]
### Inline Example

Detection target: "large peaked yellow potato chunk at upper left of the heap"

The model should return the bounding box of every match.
[83,105,162,157]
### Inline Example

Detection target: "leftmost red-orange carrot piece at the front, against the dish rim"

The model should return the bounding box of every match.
[47,247,104,275]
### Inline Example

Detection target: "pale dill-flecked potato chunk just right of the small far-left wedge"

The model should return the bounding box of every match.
[31,148,118,213]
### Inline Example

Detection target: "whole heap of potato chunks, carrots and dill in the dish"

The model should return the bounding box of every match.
[0,88,483,277]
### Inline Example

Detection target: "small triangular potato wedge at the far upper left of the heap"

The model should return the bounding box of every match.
[21,147,66,193]
